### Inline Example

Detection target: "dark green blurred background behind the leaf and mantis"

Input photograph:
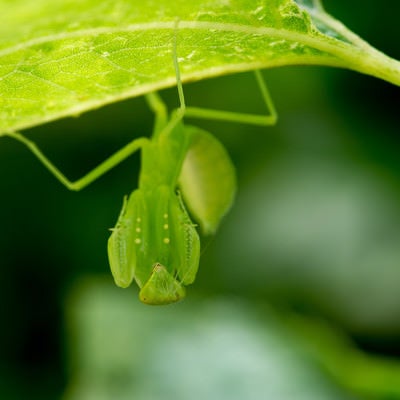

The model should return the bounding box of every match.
[0,0,400,400]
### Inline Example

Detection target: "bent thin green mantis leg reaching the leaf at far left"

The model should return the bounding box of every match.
[1,132,148,191]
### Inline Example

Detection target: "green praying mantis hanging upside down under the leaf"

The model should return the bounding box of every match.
[3,37,277,305]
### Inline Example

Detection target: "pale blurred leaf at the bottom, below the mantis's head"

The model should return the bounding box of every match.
[64,280,360,400]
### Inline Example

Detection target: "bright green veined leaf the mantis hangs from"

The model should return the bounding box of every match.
[0,0,400,133]
